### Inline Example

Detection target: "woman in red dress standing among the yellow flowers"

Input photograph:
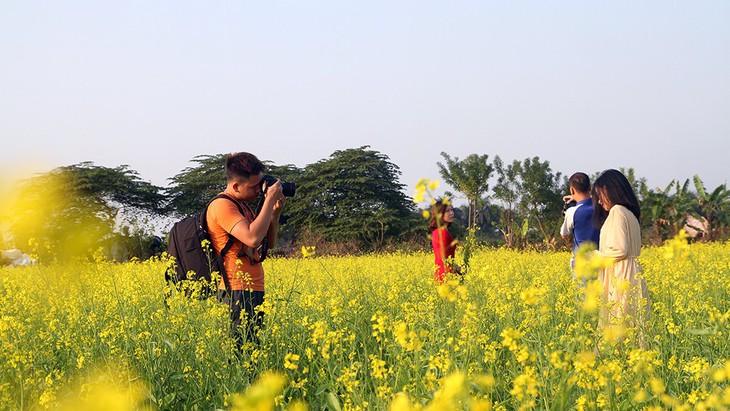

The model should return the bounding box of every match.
[428,200,460,284]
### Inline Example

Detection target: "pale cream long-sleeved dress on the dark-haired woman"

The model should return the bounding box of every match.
[598,205,649,328]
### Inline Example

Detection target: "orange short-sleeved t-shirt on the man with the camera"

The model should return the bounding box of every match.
[206,193,264,291]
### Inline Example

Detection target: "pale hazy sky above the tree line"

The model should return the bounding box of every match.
[0,0,730,201]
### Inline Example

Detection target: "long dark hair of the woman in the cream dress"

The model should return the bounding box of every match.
[591,169,641,230]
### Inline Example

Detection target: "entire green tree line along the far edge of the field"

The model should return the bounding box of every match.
[0,146,730,260]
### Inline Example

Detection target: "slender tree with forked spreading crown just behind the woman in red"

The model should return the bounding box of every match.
[436,152,494,229]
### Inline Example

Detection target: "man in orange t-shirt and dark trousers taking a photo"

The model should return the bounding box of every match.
[206,153,286,345]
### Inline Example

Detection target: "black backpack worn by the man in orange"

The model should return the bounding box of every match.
[165,194,244,297]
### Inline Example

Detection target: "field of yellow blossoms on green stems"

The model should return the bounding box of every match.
[0,239,730,410]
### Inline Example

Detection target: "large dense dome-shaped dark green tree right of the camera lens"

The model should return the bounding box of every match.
[287,146,414,250]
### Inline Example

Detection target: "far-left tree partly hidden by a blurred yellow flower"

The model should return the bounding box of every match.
[9,162,164,259]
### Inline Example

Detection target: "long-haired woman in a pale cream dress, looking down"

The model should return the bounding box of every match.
[591,170,649,343]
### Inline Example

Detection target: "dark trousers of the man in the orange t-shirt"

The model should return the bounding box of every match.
[218,290,264,348]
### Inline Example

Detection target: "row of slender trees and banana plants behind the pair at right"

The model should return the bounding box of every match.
[438,153,730,249]
